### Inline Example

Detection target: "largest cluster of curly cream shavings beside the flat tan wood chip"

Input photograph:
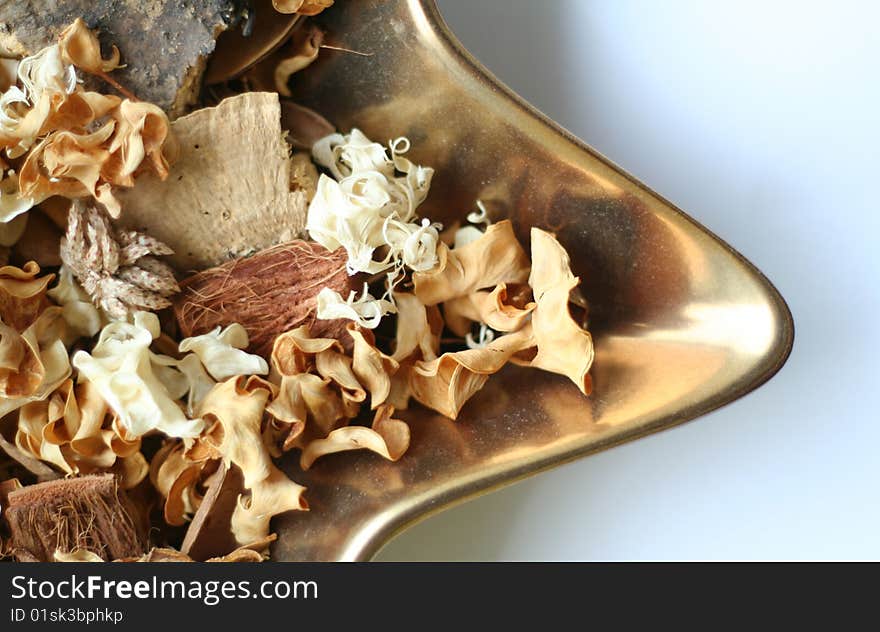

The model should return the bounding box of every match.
[306,129,439,290]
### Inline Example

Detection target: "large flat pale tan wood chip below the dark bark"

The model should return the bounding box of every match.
[119,92,313,272]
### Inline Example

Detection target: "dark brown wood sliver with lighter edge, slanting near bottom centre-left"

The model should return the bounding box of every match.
[180,465,244,562]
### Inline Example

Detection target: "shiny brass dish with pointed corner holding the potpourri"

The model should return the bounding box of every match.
[273,0,794,560]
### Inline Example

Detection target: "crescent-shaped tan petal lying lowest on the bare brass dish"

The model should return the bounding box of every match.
[300,405,410,470]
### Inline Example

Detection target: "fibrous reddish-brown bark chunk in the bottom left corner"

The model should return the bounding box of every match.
[3,474,147,562]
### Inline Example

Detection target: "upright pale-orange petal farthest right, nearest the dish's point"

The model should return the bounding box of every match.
[514,228,593,395]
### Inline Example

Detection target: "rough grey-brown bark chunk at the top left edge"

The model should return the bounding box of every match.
[0,0,239,116]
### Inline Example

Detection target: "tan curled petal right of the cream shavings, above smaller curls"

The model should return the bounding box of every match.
[413,220,531,305]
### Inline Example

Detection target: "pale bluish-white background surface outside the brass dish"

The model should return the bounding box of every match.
[379,0,880,560]
